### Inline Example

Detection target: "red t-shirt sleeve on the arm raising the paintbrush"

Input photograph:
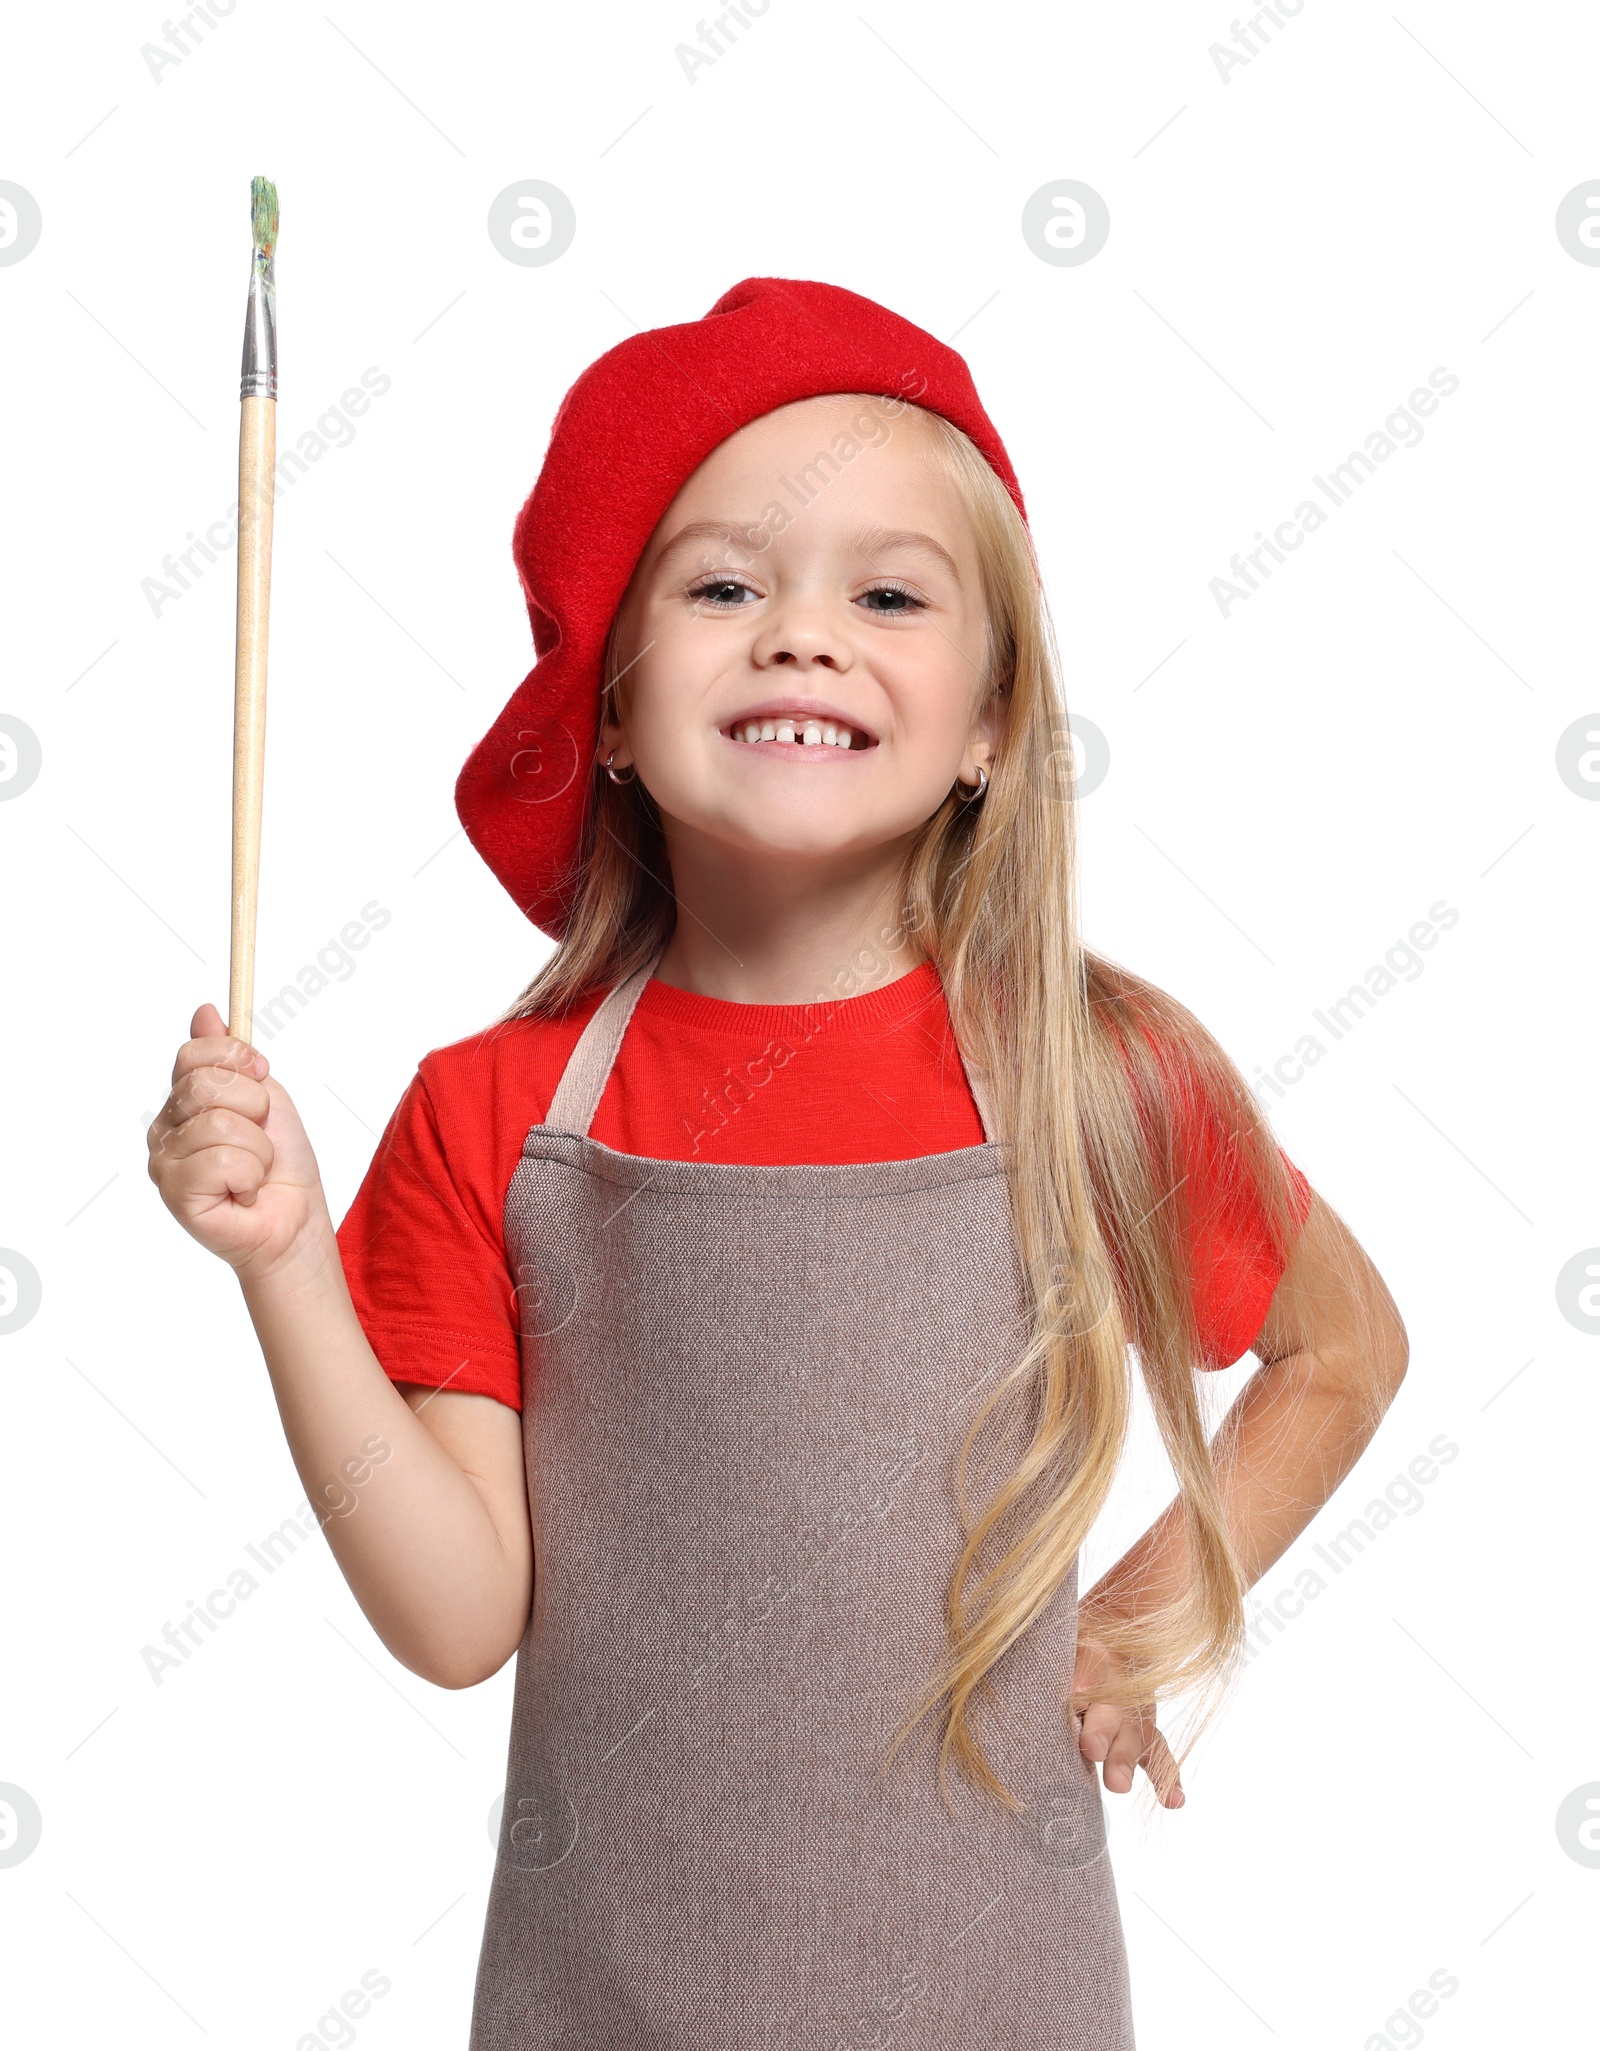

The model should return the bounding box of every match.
[338,1056,521,1409]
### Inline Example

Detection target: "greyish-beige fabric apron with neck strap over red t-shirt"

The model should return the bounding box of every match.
[470,964,1134,2051]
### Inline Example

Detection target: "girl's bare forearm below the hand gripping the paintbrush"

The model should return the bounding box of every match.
[240,1226,531,1688]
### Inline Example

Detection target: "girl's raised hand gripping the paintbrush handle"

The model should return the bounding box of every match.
[146,1005,332,1274]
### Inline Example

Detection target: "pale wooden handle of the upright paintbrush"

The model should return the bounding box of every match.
[228,398,277,1042]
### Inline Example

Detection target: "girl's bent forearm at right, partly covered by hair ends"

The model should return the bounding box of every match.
[1083,1352,1403,1614]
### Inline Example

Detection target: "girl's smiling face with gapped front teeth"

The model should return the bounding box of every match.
[601,396,997,861]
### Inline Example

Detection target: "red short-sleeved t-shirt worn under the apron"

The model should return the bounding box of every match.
[338,962,1311,1409]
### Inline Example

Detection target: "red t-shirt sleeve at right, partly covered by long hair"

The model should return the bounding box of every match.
[1179,1093,1313,1368]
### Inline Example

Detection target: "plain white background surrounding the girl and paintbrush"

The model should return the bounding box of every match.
[0,0,1600,2051]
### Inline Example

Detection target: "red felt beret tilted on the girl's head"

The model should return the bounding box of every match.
[455,277,1026,939]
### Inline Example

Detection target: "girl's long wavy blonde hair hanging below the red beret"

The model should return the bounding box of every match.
[503,395,1394,1809]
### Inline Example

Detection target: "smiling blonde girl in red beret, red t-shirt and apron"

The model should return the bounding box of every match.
[152,279,1405,2051]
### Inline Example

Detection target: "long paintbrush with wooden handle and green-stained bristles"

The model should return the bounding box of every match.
[228,178,277,1042]
